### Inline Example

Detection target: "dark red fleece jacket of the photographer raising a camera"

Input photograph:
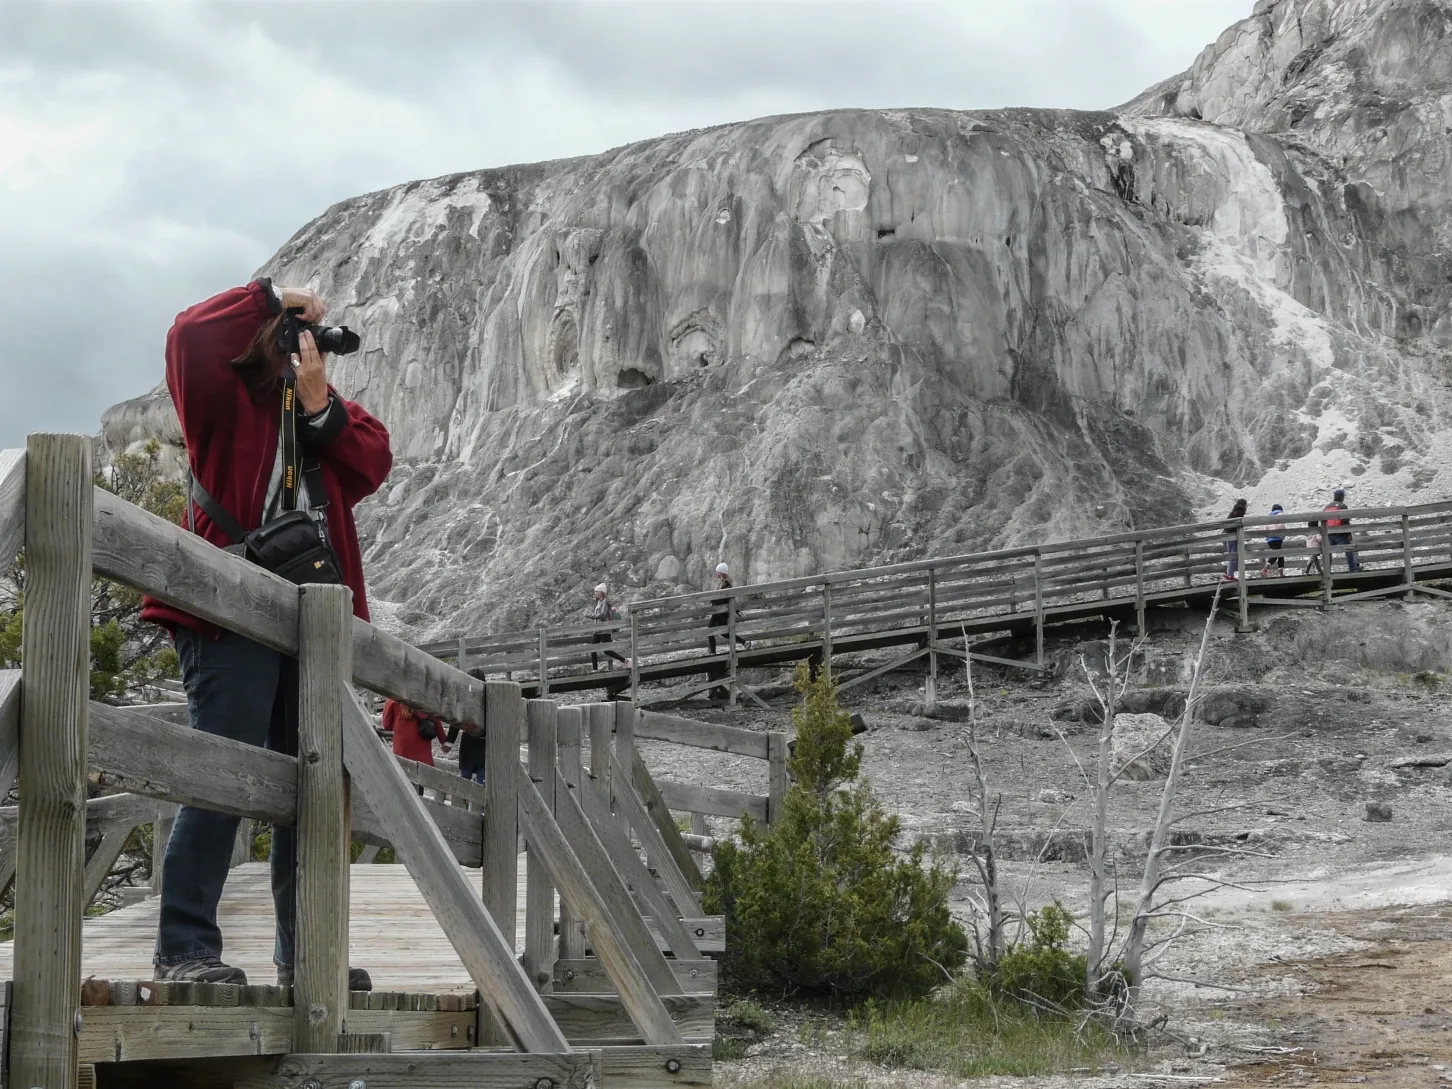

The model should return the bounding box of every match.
[141,282,393,633]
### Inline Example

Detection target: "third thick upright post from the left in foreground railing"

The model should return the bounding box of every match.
[478,682,525,1045]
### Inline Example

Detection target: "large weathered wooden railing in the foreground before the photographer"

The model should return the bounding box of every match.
[0,436,723,1089]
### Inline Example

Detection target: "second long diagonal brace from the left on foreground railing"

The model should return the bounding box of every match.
[519,771,682,1044]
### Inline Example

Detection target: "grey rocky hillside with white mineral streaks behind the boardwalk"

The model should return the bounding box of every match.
[106,0,1452,636]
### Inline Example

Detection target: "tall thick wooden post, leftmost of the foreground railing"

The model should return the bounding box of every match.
[7,434,93,1089]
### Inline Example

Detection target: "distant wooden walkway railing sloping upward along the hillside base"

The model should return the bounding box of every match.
[421,502,1452,706]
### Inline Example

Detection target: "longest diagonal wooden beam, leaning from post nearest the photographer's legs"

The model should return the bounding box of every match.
[343,685,569,1054]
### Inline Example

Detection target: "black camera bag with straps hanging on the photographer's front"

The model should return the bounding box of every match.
[187,375,343,585]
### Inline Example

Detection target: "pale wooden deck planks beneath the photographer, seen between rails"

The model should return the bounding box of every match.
[0,855,526,995]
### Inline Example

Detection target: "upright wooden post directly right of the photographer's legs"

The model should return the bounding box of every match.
[292,585,353,1053]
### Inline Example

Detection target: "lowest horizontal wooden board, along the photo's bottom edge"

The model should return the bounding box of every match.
[237,1051,589,1089]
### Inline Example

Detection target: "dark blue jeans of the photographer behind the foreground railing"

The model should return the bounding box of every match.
[155,627,298,967]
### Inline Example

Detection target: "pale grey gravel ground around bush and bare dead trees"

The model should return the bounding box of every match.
[566,603,1452,1086]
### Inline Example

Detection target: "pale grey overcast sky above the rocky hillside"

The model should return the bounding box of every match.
[0,0,1252,449]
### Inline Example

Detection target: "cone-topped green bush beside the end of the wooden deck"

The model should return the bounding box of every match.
[706,665,967,998]
